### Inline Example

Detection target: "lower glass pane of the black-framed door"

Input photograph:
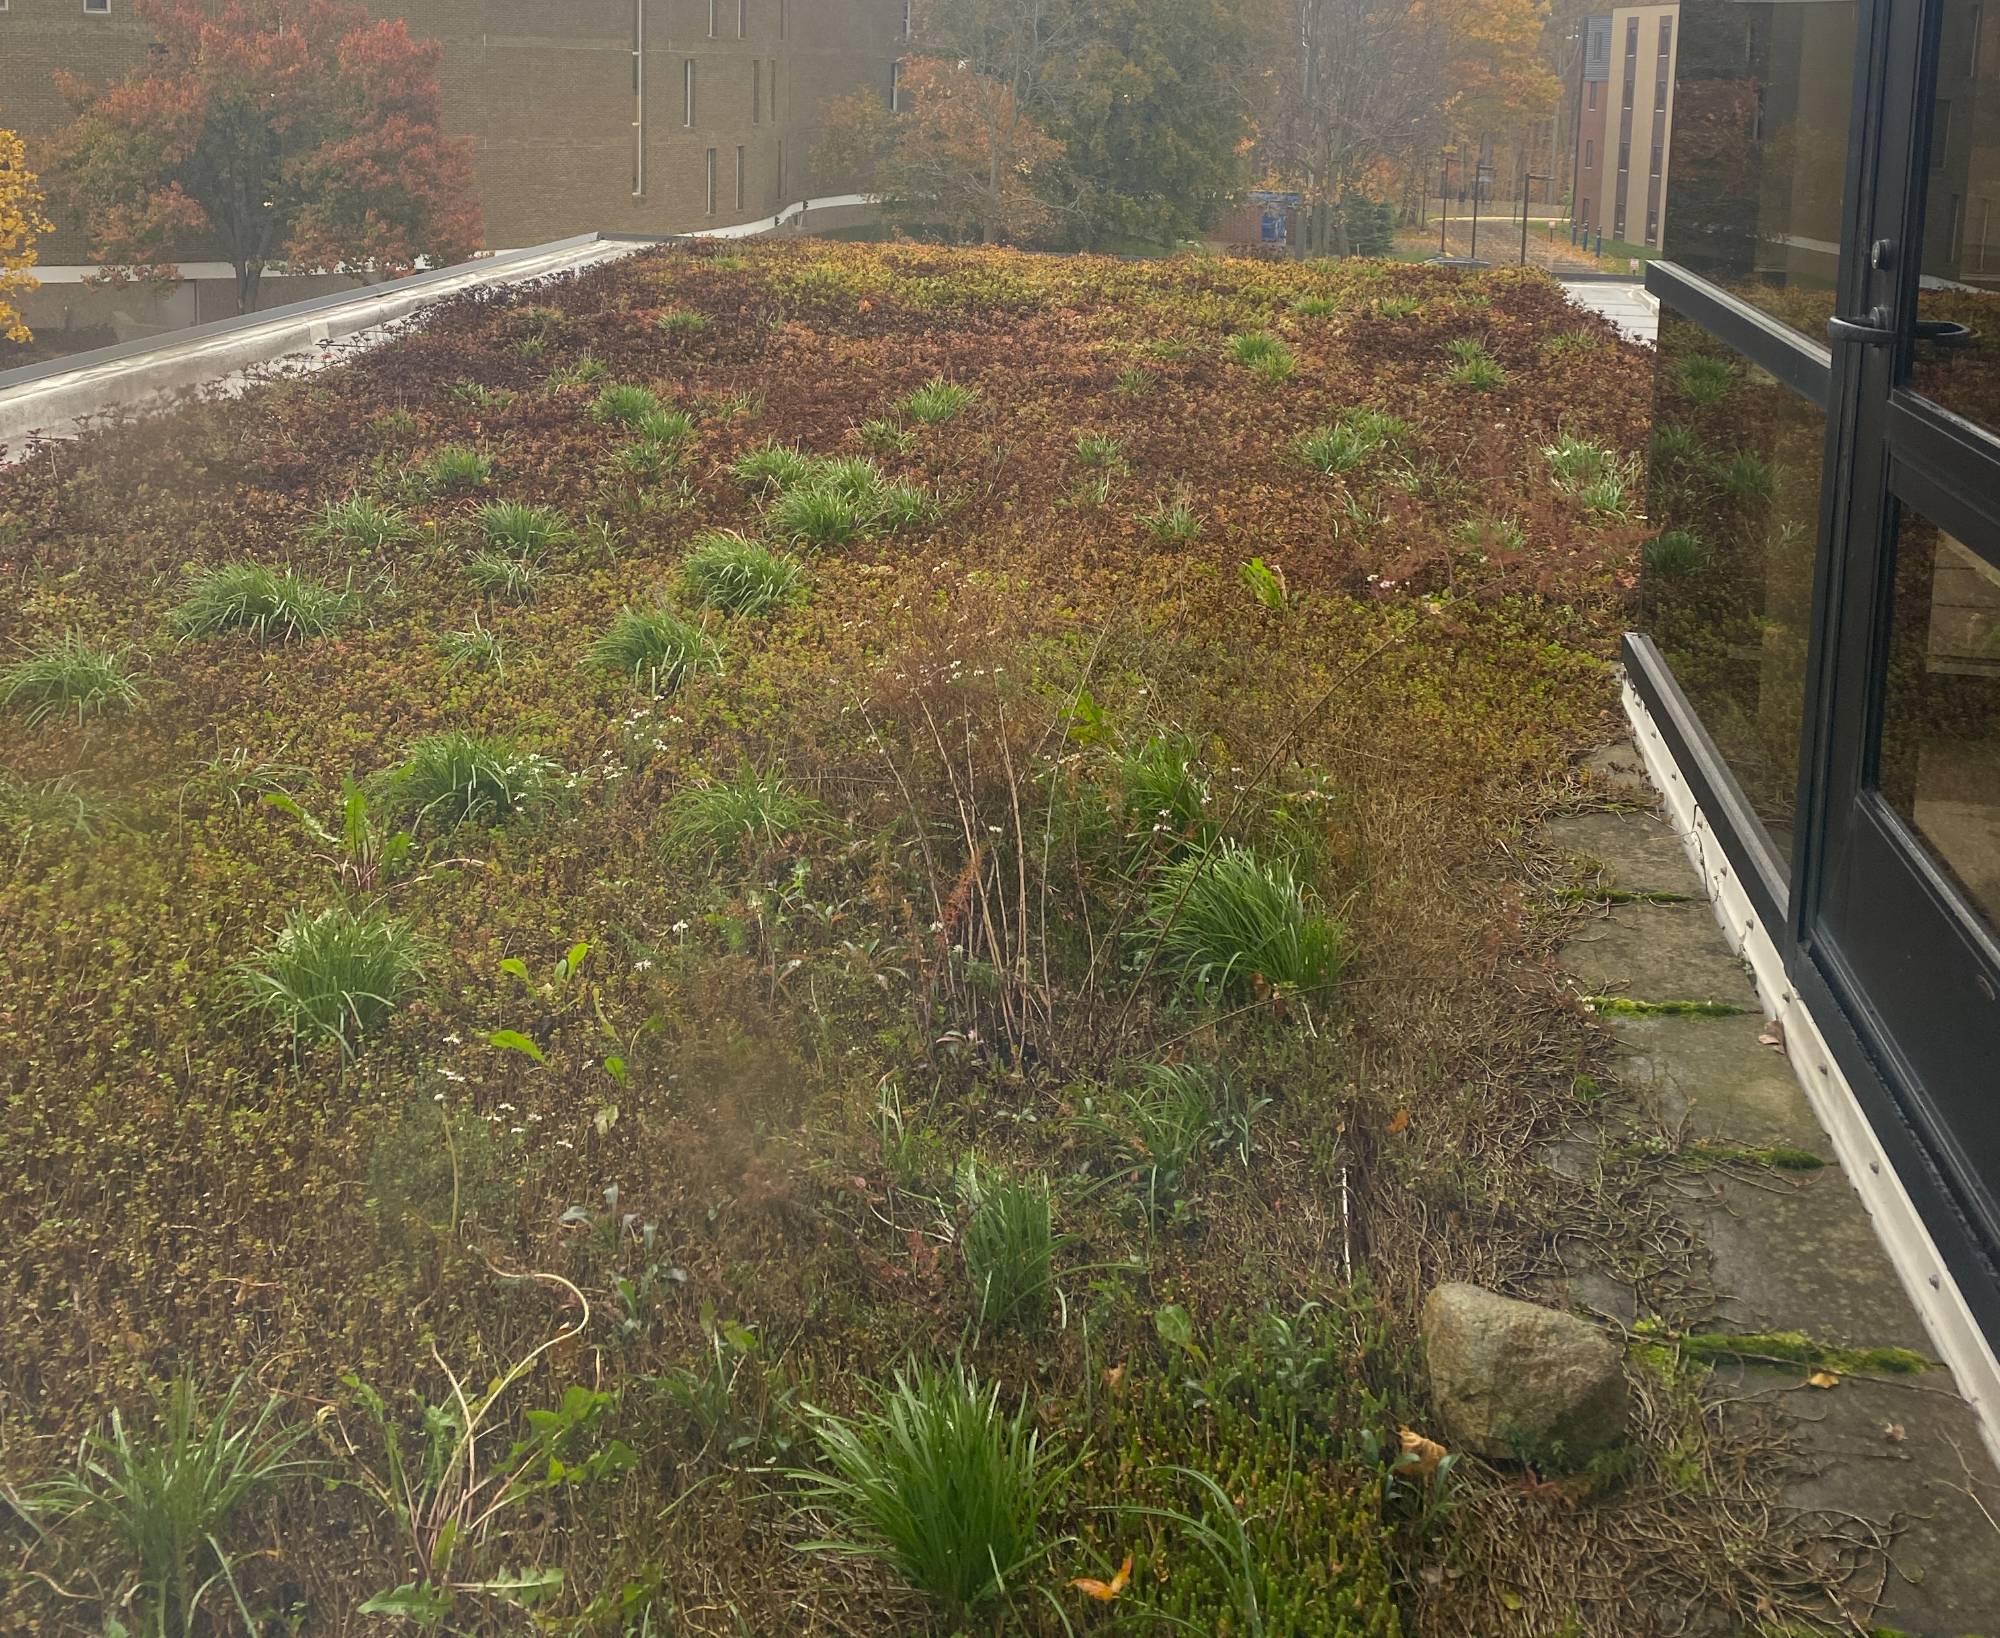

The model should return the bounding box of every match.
[1876,508,2000,926]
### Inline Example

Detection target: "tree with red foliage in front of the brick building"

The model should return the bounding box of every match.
[56,0,484,312]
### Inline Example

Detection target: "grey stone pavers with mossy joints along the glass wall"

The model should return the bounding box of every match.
[1546,746,2000,1638]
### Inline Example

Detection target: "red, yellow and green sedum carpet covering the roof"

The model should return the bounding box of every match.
[0,246,1816,1634]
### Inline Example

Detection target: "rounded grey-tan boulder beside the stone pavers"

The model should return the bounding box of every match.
[1422,1282,1632,1462]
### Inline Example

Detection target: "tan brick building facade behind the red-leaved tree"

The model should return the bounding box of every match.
[0,0,908,266]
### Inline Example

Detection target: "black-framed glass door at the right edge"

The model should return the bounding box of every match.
[1794,0,2000,1246]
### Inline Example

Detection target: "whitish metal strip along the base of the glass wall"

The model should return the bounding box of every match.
[1622,680,2000,1462]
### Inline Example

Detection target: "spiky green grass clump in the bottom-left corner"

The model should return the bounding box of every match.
[26,1372,320,1636]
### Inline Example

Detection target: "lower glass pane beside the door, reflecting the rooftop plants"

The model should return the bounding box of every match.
[1640,308,1826,872]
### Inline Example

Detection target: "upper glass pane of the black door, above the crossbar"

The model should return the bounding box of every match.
[1910,0,2000,432]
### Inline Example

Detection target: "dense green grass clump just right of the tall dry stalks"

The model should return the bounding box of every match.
[1132,842,1348,996]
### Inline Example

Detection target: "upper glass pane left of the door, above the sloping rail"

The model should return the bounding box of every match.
[1666,0,1856,340]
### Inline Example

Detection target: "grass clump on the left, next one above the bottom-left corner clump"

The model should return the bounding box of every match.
[236,906,422,1058]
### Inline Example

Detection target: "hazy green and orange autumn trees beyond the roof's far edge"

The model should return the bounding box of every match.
[818,0,1560,254]
